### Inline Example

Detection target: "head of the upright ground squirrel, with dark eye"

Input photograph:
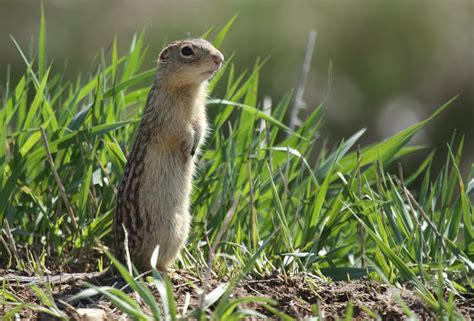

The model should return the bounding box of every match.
[158,39,224,86]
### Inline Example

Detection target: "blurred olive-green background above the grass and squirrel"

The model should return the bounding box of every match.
[0,0,474,172]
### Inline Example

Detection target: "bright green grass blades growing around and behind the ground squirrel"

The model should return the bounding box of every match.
[0,11,474,320]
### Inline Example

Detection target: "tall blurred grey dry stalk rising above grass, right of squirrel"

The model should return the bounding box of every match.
[290,30,316,130]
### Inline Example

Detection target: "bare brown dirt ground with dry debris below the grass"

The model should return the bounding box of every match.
[0,271,474,320]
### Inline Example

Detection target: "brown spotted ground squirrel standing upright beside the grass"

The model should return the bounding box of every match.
[114,39,224,270]
